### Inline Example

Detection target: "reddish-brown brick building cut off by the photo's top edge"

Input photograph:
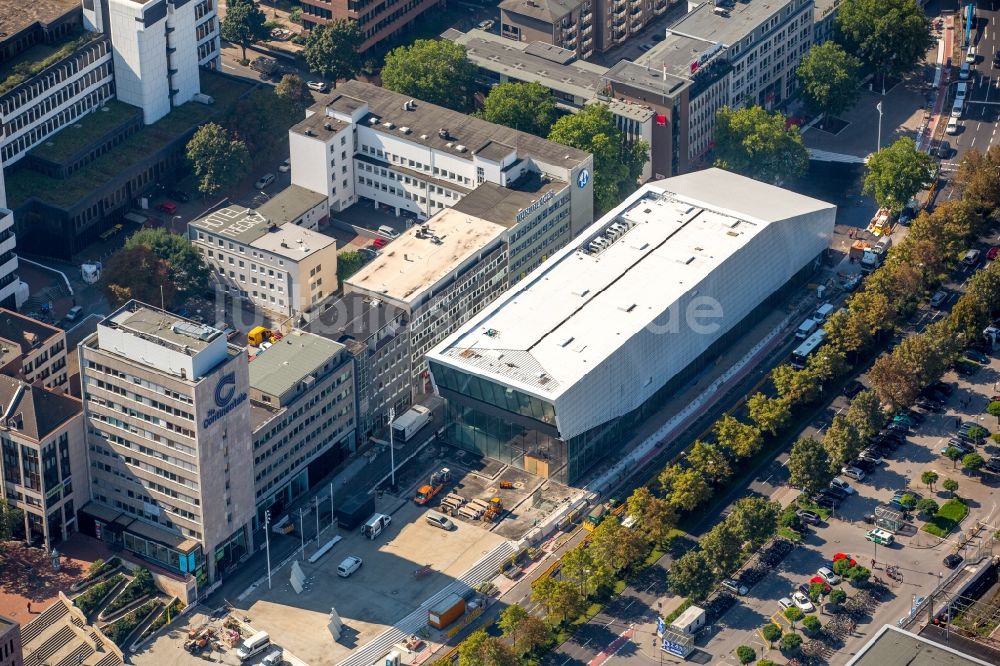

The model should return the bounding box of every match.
[302,0,444,51]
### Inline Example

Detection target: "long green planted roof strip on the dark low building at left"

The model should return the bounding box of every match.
[7,73,253,208]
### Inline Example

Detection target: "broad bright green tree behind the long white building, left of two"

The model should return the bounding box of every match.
[382,39,476,111]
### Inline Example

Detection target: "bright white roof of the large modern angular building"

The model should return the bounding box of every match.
[429,168,833,400]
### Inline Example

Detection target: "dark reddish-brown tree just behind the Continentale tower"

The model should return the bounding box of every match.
[101,245,177,310]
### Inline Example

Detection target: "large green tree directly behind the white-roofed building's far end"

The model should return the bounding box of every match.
[715,106,809,185]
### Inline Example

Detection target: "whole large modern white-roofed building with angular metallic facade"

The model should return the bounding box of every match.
[427,169,836,484]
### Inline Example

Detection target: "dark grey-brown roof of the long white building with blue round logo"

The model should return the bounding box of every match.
[306,80,588,169]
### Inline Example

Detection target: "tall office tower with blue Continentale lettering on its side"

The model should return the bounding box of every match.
[80,301,254,583]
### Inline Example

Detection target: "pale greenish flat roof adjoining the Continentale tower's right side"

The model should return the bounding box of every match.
[250,330,344,396]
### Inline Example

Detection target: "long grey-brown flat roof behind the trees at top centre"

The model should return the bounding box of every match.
[441,28,608,101]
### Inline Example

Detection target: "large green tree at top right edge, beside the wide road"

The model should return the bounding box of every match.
[836,0,933,85]
